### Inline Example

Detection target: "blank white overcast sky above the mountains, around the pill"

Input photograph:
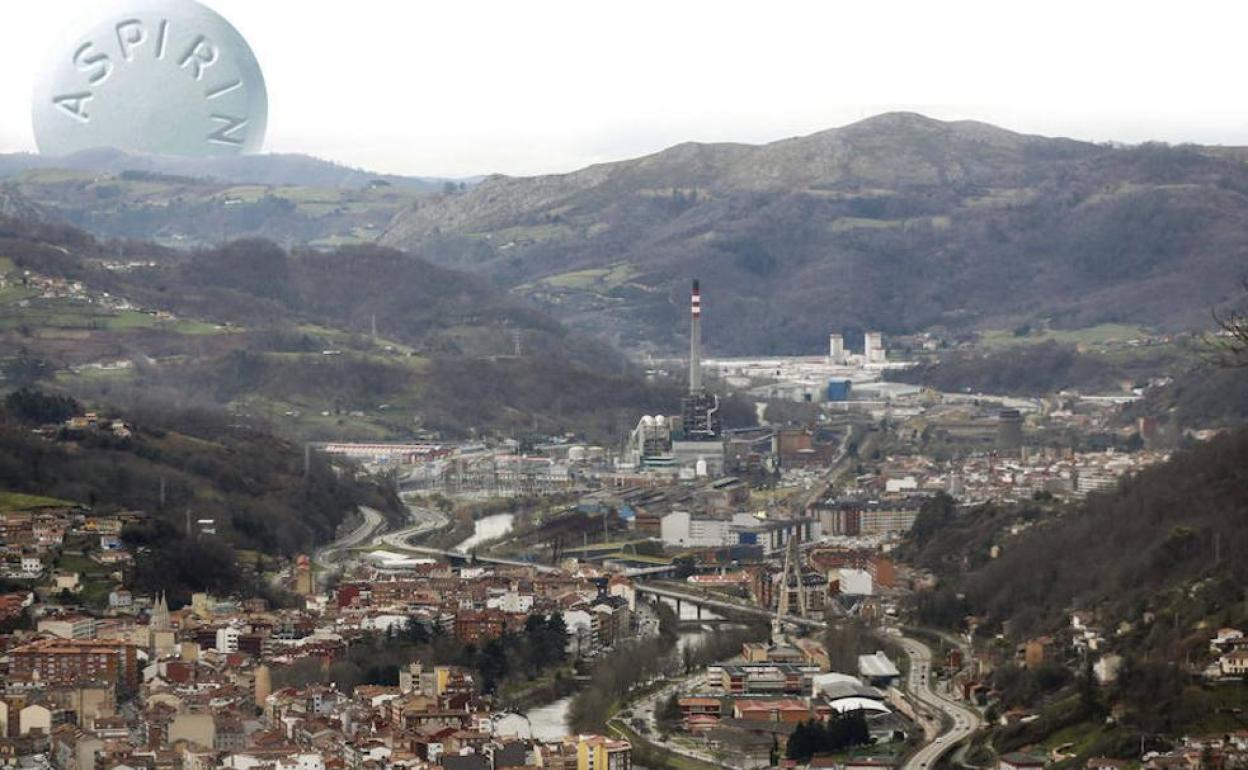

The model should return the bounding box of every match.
[0,0,1248,176]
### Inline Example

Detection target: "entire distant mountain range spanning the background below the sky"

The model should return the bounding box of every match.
[0,114,1248,354]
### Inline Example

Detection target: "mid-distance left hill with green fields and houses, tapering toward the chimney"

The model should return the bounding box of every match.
[0,221,754,441]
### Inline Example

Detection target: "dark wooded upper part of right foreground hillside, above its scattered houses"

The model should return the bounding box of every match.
[906,428,1248,643]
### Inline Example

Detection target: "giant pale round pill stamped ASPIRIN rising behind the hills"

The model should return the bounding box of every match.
[32,0,268,156]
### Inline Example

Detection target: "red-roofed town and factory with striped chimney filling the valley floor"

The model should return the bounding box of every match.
[0,274,1248,770]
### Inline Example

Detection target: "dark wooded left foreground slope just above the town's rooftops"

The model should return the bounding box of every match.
[0,389,407,605]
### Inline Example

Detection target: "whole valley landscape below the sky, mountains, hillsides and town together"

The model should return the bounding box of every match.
[0,107,1248,770]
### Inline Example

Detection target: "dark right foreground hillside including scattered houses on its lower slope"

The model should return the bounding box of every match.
[902,428,1248,748]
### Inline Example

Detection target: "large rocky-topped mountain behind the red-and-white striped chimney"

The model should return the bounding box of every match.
[382,114,1248,353]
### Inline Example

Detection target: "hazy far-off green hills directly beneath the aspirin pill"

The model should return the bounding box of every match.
[0,149,474,248]
